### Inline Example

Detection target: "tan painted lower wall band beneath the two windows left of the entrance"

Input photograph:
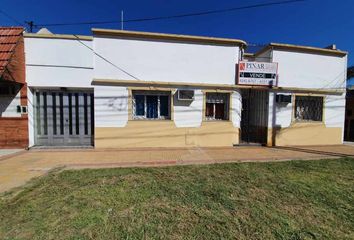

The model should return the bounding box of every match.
[95,121,239,148]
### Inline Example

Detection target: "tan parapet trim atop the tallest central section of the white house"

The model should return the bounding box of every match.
[92,28,247,46]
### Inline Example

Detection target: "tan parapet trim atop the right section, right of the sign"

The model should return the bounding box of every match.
[254,43,348,57]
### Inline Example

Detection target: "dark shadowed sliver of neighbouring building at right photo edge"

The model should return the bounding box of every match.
[344,66,354,142]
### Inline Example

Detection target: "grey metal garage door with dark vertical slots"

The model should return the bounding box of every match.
[34,90,94,146]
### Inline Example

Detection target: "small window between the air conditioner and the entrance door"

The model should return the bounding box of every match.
[205,93,230,120]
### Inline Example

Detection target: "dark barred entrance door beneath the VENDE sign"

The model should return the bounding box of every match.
[241,89,269,144]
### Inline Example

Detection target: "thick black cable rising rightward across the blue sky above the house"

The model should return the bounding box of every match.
[36,0,306,27]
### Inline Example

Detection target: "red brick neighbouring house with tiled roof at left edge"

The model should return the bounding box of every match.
[0,27,28,148]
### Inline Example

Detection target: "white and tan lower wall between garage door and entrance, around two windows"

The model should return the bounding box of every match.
[95,86,241,148]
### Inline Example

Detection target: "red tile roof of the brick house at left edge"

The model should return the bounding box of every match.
[0,27,24,76]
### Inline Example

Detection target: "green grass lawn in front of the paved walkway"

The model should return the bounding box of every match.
[0,158,354,239]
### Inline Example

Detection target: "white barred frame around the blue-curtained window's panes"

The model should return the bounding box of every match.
[132,90,171,121]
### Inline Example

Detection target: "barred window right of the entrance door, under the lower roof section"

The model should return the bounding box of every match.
[295,96,323,122]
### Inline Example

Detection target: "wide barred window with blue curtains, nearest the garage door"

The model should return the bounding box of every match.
[133,91,171,120]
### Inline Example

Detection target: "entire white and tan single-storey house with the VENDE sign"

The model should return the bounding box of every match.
[4,29,347,148]
